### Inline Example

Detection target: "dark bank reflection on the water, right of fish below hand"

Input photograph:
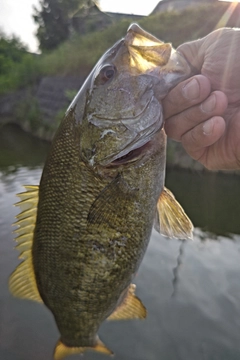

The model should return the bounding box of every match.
[166,169,240,234]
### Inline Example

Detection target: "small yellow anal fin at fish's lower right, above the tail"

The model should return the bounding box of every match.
[108,284,147,320]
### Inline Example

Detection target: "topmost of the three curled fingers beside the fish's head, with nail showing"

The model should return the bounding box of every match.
[162,75,211,119]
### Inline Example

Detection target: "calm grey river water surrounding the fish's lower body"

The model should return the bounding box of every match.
[0,126,240,360]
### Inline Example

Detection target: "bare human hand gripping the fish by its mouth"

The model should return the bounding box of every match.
[163,28,240,170]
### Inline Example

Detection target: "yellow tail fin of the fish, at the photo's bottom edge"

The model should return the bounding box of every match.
[53,337,113,360]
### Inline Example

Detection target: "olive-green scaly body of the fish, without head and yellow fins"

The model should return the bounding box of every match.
[33,107,165,346]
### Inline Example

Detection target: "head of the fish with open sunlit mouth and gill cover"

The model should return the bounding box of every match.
[72,24,191,167]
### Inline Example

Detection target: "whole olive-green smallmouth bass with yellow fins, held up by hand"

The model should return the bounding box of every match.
[9,24,192,360]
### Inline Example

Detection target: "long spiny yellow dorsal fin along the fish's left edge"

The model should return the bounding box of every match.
[9,186,42,302]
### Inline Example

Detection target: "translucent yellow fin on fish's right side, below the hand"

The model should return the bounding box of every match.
[154,188,193,239]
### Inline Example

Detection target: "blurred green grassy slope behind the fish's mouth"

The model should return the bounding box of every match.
[0,2,240,94]
